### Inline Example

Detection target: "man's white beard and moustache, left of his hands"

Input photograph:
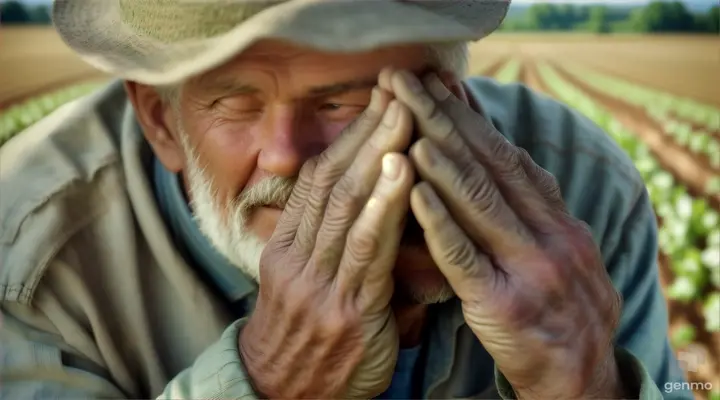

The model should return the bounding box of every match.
[178,125,295,282]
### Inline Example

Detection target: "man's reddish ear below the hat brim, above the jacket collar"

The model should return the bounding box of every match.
[125,81,185,173]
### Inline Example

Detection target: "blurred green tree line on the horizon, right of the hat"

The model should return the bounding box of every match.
[501,1,720,35]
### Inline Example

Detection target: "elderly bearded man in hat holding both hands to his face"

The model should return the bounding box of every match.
[0,0,690,399]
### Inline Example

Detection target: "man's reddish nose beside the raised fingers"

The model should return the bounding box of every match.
[257,111,330,177]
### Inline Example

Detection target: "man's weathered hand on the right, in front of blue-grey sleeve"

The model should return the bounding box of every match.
[381,71,623,399]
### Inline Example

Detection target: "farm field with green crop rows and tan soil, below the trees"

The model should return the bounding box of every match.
[0,28,720,399]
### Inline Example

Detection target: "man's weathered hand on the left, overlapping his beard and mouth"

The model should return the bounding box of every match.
[240,89,414,399]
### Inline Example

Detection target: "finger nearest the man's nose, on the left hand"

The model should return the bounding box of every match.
[292,87,390,259]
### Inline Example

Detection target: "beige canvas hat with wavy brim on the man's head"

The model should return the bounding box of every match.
[52,0,510,85]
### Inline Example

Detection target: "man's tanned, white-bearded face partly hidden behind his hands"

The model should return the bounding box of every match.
[168,41,452,303]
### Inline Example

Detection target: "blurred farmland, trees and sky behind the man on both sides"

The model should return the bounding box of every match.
[0,0,720,399]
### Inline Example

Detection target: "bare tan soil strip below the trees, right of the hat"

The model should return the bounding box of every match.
[472,34,720,106]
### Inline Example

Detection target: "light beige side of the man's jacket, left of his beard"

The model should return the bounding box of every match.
[0,83,252,399]
